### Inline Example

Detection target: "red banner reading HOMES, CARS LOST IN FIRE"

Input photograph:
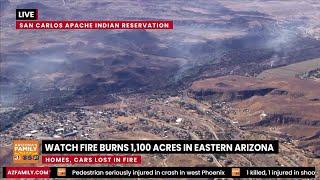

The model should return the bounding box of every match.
[42,155,141,164]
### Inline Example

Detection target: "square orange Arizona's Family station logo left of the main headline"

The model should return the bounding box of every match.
[13,140,40,164]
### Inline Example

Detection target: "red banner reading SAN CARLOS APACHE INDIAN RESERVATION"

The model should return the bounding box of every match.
[16,20,173,30]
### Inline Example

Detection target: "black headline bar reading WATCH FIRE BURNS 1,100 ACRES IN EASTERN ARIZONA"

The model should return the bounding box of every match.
[41,140,279,154]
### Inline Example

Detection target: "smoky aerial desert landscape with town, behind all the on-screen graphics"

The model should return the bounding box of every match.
[0,0,320,174]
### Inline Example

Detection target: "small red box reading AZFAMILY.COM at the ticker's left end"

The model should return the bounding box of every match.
[3,167,50,178]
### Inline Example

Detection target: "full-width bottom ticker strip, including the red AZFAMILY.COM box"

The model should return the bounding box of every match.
[3,167,316,178]
